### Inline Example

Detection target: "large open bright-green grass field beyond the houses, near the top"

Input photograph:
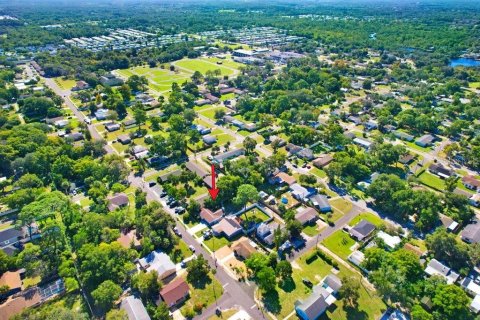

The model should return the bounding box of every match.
[116,57,241,95]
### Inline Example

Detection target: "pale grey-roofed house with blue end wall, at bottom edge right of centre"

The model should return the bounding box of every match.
[295,275,342,320]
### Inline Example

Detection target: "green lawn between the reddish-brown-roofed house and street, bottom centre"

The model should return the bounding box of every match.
[180,274,223,313]
